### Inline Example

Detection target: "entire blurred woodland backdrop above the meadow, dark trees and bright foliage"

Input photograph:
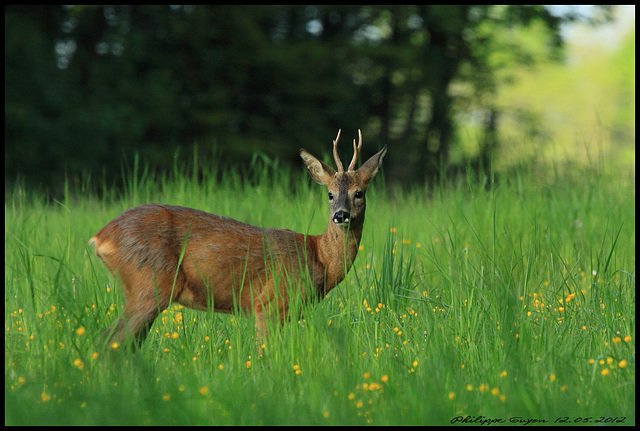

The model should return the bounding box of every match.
[5,5,635,196]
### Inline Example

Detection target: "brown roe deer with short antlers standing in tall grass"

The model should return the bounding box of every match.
[89,130,387,353]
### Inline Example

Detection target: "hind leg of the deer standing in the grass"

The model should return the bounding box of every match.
[102,270,175,350]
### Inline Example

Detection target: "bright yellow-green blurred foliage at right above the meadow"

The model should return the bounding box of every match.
[496,22,635,170]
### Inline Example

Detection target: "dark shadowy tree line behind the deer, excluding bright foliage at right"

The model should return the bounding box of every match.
[5,5,607,192]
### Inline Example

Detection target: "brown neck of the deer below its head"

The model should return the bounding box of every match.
[315,221,362,294]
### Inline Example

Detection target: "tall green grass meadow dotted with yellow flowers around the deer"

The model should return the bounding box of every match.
[5,152,635,425]
